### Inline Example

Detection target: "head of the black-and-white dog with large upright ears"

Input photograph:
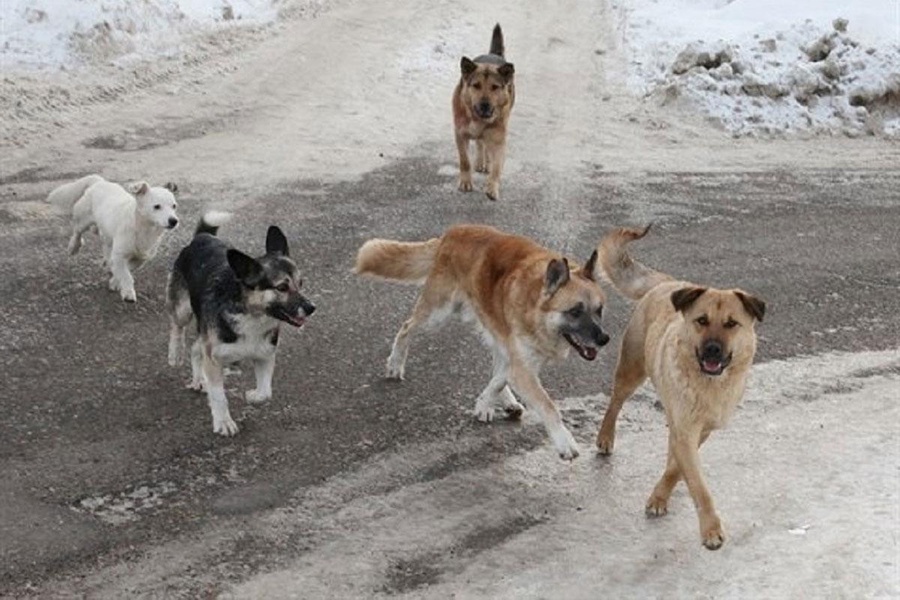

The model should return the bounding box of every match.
[227,225,316,327]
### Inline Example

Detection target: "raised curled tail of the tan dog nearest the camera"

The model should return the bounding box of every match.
[598,225,672,300]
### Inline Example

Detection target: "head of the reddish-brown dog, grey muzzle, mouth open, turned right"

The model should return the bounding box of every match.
[541,251,609,360]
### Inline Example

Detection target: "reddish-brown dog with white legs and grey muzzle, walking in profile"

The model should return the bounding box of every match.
[355,225,609,460]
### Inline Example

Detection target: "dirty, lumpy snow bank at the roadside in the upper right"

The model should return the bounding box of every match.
[628,0,900,137]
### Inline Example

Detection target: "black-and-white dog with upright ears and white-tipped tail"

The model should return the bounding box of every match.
[166,211,316,436]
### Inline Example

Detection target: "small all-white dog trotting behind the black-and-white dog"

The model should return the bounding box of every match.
[47,175,178,302]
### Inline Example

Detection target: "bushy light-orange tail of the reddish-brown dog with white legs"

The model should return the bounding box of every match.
[354,238,441,283]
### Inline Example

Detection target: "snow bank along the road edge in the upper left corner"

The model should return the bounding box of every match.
[0,0,278,70]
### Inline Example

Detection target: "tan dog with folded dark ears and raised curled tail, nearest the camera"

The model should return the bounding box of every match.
[597,227,766,550]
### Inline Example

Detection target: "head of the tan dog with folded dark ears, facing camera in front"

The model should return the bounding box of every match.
[671,286,766,377]
